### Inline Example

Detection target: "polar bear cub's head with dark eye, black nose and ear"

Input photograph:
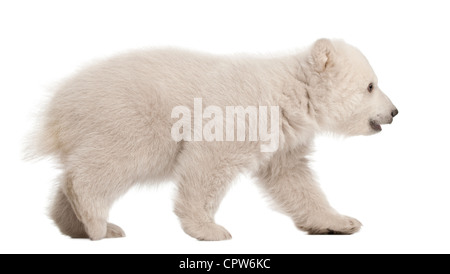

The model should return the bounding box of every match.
[303,39,398,136]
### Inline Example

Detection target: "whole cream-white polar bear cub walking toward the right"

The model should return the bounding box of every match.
[31,39,398,241]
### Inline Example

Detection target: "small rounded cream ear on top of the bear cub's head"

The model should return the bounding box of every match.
[311,39,336,72]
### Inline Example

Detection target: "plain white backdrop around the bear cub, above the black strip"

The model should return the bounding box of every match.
[0,0,450,253]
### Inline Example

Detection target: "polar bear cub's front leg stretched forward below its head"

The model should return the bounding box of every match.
[257,147,362,234]
